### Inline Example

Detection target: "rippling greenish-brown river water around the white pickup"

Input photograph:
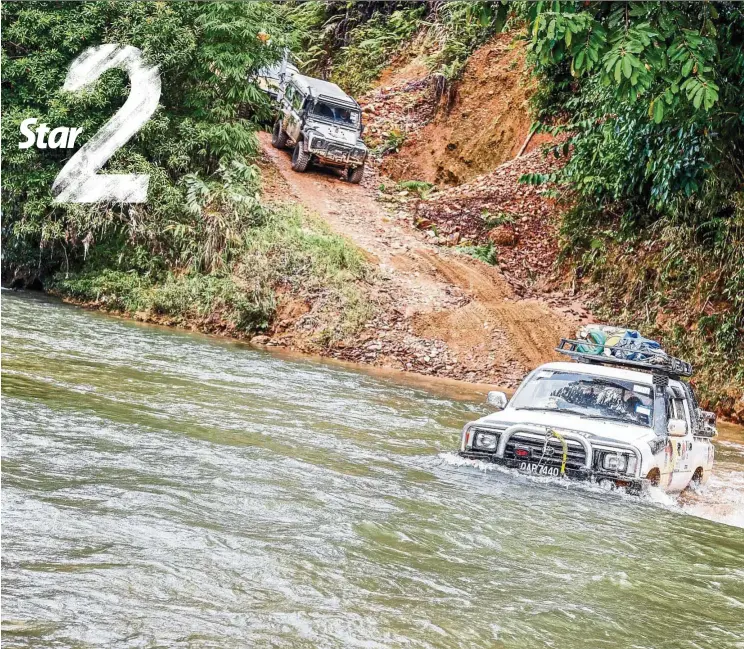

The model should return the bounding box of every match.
[2,291,744,649]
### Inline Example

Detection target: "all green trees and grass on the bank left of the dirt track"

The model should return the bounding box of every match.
[2,2,370,341]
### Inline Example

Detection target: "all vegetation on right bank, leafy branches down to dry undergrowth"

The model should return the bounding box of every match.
[522,2,744,404]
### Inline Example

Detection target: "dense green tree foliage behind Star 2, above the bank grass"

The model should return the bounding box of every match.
[2,1,281,279]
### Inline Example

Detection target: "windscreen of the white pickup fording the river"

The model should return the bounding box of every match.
[510,370,654,426]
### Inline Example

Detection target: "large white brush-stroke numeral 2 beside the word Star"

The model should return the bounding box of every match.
[52,44,160,203]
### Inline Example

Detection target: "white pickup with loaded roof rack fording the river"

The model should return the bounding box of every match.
[460,339,717,493]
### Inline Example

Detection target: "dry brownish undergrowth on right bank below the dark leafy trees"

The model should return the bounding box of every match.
[564,216,744,412]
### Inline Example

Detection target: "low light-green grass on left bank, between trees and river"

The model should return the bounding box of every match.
[50,207,373,344]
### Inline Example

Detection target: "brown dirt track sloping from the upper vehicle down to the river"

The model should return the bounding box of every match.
[260,133,592,387]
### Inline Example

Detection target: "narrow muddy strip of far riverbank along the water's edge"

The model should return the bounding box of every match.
[35,290,744,425]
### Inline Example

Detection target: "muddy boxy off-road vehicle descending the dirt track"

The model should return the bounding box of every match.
[271,74,368,183]
